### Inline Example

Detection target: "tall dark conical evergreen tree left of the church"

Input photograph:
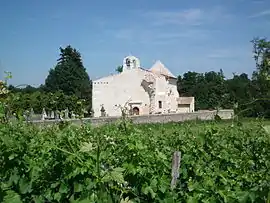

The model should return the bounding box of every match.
[45,45,92,109]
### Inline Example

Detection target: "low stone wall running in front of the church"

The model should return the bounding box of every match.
[33,109,234,126]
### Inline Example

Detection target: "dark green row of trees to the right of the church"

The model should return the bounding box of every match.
[177,38,270,118]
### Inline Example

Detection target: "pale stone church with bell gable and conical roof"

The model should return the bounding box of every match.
[92,56,194,117]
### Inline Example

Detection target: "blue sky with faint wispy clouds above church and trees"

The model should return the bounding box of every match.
[0,0,270,85]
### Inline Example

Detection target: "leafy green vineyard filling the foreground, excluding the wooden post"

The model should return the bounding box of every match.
[0,120,270,203]
